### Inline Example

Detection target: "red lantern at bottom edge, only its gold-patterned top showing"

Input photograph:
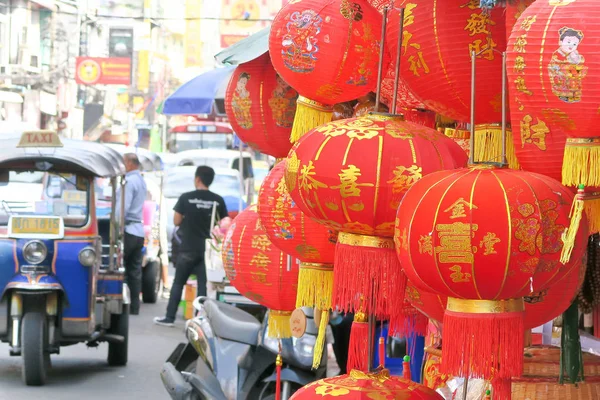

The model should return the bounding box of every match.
[290,369,443,400]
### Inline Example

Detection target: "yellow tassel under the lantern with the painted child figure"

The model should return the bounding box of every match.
[562,138,600,186]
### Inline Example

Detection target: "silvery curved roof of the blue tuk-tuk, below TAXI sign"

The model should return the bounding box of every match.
[0,135,126,178]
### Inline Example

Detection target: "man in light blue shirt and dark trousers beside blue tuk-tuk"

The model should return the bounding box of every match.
[117,153,146,315]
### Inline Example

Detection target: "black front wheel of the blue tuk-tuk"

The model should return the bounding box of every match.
[21,312,50,386]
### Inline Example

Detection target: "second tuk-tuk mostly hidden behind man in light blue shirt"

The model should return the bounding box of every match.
[101,144,169,303]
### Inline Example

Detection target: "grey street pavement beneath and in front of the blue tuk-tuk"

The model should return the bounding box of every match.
[0,299,186,400]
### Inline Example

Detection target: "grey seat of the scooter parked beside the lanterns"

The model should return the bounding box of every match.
[204,299,261,346]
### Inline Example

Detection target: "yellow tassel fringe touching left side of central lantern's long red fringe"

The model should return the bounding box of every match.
[296,262,333,310]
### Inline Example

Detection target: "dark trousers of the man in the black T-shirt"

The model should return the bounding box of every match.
[167,252,206,321]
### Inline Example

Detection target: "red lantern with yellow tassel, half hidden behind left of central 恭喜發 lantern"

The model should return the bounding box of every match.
[258,162,337,368]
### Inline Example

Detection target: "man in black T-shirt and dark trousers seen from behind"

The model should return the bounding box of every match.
[154,166,227,326]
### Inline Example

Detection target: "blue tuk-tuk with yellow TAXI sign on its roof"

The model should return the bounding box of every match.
[0,131,130,385]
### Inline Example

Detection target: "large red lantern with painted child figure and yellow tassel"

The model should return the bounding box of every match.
[507,0,600,186]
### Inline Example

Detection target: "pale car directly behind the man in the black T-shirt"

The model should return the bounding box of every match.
[163,166,246,257]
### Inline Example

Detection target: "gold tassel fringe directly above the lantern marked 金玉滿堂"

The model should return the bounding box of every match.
[473,125,521,169]
